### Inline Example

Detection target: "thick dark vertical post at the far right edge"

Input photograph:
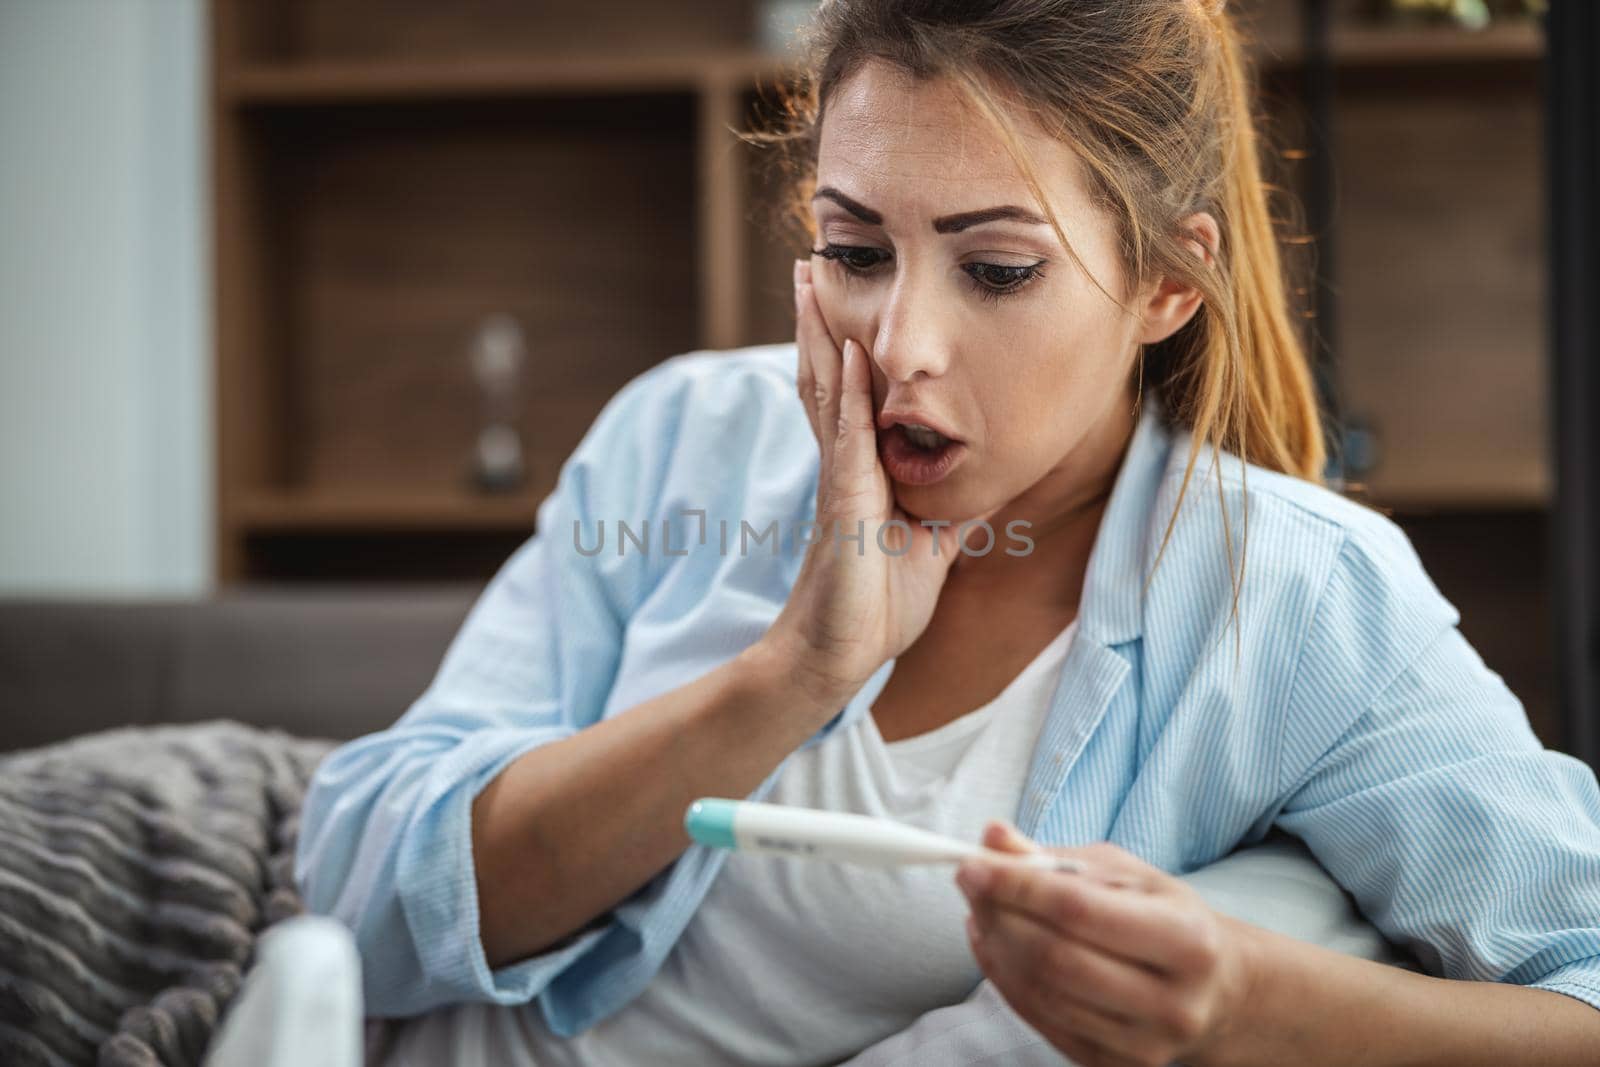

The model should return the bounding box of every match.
[1544,0,1600,768]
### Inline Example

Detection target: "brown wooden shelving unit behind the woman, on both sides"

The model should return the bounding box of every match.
[211,0,1546,582]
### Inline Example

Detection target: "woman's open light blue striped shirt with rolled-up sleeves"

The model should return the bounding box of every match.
[296,344,1600,1035]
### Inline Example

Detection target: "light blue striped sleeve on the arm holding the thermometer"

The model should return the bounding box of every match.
[1277,534,1600,1006]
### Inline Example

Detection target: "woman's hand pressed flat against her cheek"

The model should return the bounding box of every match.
[768,259,987,702]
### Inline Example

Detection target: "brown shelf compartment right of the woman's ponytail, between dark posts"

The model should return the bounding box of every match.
[1336,77,1550,507]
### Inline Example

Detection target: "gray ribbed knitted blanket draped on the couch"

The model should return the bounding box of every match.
[0,721,331,1067]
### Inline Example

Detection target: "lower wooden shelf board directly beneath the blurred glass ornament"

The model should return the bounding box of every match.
[234,485,554,534]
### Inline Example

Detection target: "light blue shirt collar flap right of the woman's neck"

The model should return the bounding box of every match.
[1078,396,1171,645]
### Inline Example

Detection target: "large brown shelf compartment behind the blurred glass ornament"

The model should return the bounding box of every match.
[246,96,698,493]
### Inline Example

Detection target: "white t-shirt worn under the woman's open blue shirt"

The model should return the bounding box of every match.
[384,622,1077,1067]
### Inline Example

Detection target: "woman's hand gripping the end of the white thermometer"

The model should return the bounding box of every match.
[957,824,1253,1067]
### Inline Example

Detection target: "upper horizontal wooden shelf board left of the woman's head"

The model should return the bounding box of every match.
[221,51,789,107]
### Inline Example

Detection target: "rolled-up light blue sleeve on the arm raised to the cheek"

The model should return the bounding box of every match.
[296,360,678,1016]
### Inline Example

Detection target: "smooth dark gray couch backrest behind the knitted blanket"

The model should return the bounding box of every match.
[0,585,478,752]
